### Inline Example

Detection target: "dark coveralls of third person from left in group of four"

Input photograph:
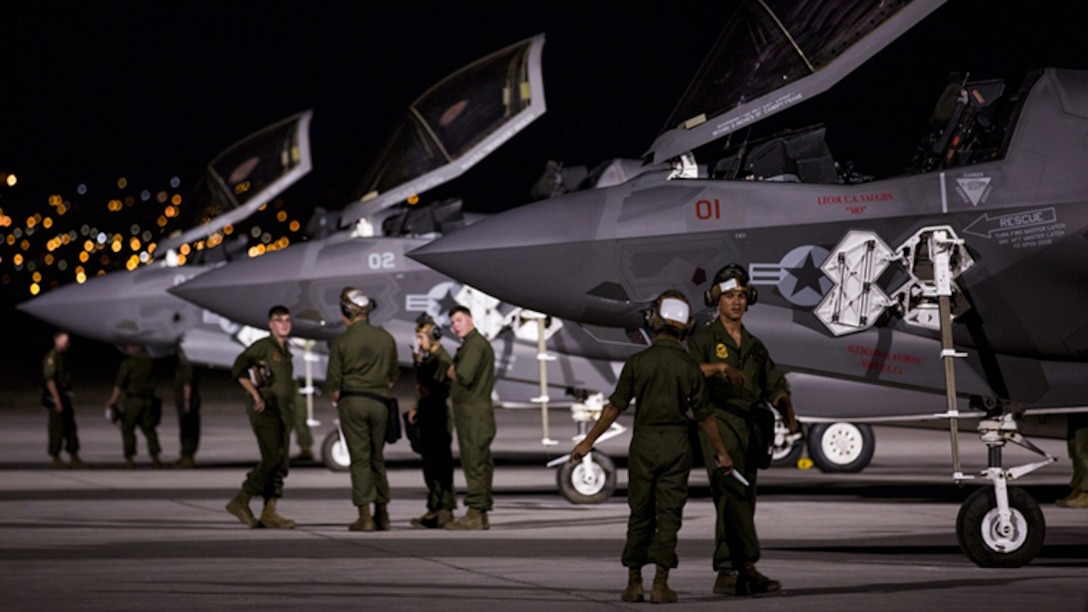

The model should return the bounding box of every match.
[416,344,457,512]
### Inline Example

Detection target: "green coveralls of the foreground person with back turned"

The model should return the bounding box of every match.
[608,338,714,568]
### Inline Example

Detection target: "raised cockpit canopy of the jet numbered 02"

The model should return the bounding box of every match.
[341,35,545,227]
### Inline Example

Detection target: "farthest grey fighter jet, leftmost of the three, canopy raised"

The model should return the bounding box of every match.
[17,111,312,367]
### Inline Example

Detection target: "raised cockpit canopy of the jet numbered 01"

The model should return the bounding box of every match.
[643,0,944,163]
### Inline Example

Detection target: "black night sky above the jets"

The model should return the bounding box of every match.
[0,0,1088,384]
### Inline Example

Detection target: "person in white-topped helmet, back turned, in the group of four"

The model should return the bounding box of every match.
[325,287,400,531]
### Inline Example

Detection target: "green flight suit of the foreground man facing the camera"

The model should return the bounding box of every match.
[688,319,789,571]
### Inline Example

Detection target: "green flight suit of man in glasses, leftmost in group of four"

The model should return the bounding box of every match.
[231,335,295,500]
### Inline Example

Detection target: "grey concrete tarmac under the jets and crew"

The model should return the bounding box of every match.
[0,378,1088,612]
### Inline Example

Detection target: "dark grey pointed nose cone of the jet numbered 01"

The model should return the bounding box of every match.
[408,189,630,325]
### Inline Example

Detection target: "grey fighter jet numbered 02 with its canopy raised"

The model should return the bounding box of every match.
[170,36,657,500]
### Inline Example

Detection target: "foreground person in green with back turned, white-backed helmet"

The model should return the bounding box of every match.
[570,291,733,603]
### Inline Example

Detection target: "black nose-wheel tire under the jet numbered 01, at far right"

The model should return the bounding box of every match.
[955,487,1047,567]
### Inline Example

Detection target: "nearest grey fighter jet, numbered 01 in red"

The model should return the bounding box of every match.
[409,0,1088,566]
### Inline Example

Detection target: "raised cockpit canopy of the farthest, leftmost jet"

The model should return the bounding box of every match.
[156,111,313,254]
